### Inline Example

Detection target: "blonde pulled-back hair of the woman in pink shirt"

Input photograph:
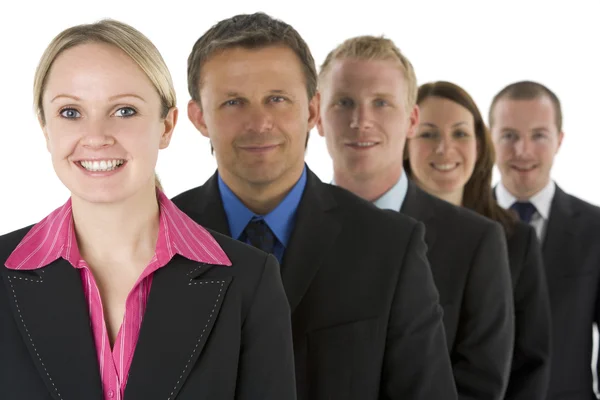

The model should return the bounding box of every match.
[33,19,177,190]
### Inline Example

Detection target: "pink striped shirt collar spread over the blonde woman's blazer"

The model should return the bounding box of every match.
[5,189,231,270]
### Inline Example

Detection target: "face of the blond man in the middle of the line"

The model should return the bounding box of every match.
[317,59,419,184]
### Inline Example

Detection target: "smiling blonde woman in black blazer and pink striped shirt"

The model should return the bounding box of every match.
[0,21,295,400]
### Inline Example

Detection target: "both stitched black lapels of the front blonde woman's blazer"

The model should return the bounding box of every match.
[2,256,231,400]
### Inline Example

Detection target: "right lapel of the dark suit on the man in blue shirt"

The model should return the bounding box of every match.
[281,167,341,312]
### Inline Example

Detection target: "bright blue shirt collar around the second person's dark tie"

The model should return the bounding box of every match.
[218,165,307,247]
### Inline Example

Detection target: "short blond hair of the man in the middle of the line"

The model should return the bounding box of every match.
[319,35,417,109]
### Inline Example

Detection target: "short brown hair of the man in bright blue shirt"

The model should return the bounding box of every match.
[188,13,317,104]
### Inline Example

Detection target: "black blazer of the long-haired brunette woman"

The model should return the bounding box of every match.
[505,222,552,400]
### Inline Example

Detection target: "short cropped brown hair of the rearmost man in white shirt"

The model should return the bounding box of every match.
[488,81,563,132]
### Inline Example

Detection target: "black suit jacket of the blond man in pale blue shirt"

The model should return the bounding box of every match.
[400,182,514,400]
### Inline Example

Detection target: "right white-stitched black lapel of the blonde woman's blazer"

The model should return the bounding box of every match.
[125,256,232,399]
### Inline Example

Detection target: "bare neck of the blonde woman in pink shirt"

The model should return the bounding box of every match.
[72,186,159,272]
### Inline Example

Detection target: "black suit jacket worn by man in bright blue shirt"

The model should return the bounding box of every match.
[174,170,456,400]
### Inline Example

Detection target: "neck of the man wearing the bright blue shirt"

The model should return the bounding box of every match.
[219,163,304,215]
